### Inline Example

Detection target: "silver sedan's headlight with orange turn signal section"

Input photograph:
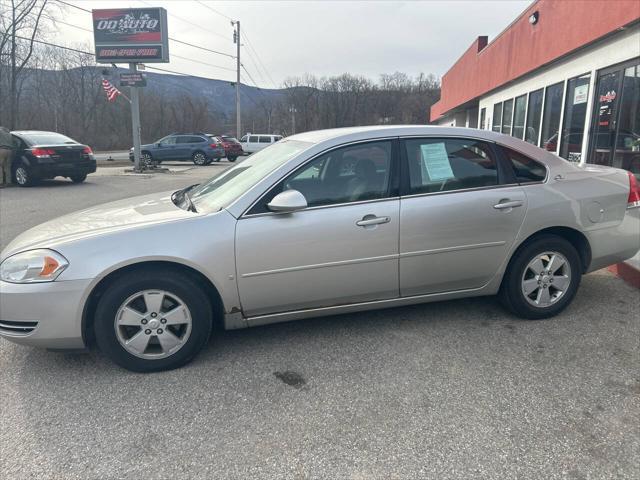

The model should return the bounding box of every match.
[0,249,69,283]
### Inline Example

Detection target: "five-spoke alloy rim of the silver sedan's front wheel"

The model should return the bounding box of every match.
[114,290,192,360]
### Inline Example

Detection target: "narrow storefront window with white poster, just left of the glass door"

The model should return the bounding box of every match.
[560,75,591,162]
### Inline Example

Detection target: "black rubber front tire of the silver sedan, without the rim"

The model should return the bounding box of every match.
[94,268,213,372]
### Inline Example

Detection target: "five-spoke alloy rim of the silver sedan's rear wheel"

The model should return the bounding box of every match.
[521,252,571,308]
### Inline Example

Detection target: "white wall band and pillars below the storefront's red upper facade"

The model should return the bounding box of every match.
[478,24,640,162]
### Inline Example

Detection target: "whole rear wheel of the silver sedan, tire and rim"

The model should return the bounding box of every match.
[500,235,582,320]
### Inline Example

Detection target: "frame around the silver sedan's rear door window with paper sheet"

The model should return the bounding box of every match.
[399,135,518,197]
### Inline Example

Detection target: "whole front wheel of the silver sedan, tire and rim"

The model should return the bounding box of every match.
[94,269,212,372]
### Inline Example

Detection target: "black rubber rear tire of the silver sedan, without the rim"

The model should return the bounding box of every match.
[499,235,583,320]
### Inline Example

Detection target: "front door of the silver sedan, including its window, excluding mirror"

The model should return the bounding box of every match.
[236,140,400,317]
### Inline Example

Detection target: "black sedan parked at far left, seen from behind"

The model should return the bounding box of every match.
[11,130,96,187]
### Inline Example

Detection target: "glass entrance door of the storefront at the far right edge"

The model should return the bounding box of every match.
[589,59,640,176]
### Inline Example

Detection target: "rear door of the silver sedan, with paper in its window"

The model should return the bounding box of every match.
[400,133,527,296]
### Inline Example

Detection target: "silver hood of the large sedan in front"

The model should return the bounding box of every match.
[0,192,198,259]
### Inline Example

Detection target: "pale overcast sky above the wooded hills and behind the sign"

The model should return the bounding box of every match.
[50,0,531,87]
